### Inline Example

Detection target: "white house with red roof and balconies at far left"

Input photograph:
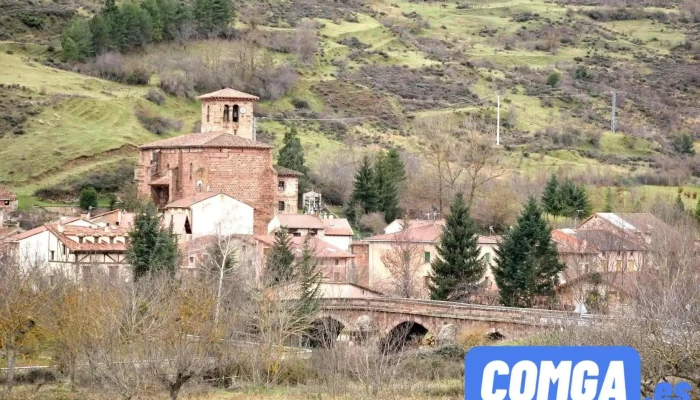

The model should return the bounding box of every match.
[8,218,130,279]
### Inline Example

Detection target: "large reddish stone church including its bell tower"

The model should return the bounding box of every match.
[135,89,299,234]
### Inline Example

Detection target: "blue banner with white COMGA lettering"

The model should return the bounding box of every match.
[464,346,642,400]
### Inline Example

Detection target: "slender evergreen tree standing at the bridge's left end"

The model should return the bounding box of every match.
[295,236,323,320]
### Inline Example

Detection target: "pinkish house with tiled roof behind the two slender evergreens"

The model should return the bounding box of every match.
[255,235,355,283]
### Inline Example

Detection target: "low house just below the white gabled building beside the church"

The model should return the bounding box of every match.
[178,234,258,284]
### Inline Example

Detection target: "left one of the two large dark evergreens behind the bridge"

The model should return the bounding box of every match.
[429,193,486,300]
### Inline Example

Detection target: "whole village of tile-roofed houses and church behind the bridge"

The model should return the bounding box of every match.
[0,89,680,313]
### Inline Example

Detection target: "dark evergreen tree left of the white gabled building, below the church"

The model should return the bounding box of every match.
[126,204,180,279]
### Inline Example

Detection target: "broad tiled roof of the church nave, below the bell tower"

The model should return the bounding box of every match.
[139,132,272,150]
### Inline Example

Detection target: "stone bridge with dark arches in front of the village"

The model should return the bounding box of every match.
[320,297,600,346]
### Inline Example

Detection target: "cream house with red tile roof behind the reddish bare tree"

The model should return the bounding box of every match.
[364,220,498,296]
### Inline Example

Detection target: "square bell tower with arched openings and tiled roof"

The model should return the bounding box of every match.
[197,88,259,140]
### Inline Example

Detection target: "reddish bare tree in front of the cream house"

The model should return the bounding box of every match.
[381,225,425,298]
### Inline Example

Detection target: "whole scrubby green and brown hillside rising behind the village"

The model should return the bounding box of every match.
[0,0,700,211]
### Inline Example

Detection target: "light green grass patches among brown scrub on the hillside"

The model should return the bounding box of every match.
[0,0,684,206]
